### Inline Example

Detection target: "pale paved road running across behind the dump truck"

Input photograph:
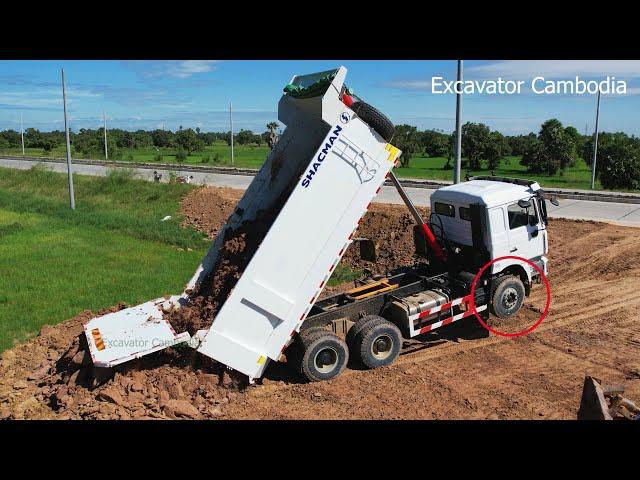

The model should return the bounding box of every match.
[0,158,640,227]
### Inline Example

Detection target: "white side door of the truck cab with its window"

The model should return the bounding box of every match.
[507,197,544,259]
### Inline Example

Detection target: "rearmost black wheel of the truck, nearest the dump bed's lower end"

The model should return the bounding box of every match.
[299,329,349,382]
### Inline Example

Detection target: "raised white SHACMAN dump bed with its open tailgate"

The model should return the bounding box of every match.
[85,67,400,379]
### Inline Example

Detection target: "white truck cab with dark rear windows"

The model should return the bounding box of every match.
[429,177,549,294]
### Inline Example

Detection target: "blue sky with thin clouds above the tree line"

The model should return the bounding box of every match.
[0,60,640,135]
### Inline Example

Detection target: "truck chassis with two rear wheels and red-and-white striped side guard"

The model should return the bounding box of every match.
[283,264,500,381]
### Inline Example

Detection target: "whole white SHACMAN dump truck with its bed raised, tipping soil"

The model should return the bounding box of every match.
[85,67,548,381]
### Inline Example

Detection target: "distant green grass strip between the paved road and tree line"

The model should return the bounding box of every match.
[0,143,616,189]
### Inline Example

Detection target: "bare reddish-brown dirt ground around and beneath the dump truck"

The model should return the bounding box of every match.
[0,188,640,419]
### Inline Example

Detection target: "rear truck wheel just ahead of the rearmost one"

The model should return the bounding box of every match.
[350,317,402,368]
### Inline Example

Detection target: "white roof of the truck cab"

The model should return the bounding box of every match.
[431,180,540,207]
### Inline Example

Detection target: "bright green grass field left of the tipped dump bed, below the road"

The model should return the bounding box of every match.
[0,168,209,351]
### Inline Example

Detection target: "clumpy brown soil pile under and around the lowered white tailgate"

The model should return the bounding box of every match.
[0,305,243,419]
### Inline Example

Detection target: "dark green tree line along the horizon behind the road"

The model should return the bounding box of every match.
[0,119,640,189]
